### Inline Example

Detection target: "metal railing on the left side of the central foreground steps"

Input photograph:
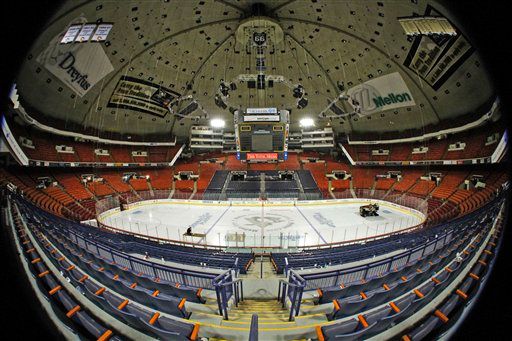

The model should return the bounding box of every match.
[212,269,244,320]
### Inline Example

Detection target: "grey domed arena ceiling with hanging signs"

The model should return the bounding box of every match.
[16,0,494,137]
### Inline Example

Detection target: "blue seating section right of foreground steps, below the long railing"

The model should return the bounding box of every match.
[314,206,499,340]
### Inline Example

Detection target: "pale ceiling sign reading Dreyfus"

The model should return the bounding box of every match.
[36,19,114,97]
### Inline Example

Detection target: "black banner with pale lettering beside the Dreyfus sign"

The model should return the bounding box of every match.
[107,76,181,117]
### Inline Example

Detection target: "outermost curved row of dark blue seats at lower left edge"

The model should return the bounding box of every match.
[12,210,121,340]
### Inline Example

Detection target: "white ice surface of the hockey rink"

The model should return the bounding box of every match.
[98,199,425,248]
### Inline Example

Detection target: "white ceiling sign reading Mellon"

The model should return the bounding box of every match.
[347,72,416,115]
